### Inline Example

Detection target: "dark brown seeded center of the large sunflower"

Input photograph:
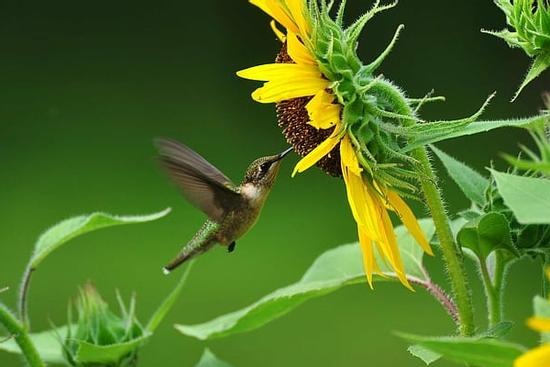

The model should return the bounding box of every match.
[275,43,342,177]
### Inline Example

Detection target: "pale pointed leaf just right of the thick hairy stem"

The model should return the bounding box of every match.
[430,146,489,206]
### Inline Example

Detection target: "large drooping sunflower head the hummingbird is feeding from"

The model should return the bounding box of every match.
[237,0,433,289]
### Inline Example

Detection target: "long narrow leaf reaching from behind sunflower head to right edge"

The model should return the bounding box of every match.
[400,114,550,153]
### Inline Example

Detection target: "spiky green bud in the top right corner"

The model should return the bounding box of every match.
[484,0,550,99]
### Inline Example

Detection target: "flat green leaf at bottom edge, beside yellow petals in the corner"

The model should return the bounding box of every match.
[399,334,524,367]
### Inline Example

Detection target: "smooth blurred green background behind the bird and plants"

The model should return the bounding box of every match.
[0,0,550,367]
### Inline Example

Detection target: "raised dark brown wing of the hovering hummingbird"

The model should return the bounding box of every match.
[155,139,240,222]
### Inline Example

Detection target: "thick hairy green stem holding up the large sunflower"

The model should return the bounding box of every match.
[373,80,475,336]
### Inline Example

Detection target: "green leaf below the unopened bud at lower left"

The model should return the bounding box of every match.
[75,334,152,365]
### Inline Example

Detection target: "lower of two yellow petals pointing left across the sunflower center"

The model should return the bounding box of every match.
[252,77,328,103]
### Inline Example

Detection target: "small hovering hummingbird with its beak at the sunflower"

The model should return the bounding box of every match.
[155,138,292,274]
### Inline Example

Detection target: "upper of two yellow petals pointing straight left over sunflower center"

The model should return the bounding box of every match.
[237,64,322,82]
